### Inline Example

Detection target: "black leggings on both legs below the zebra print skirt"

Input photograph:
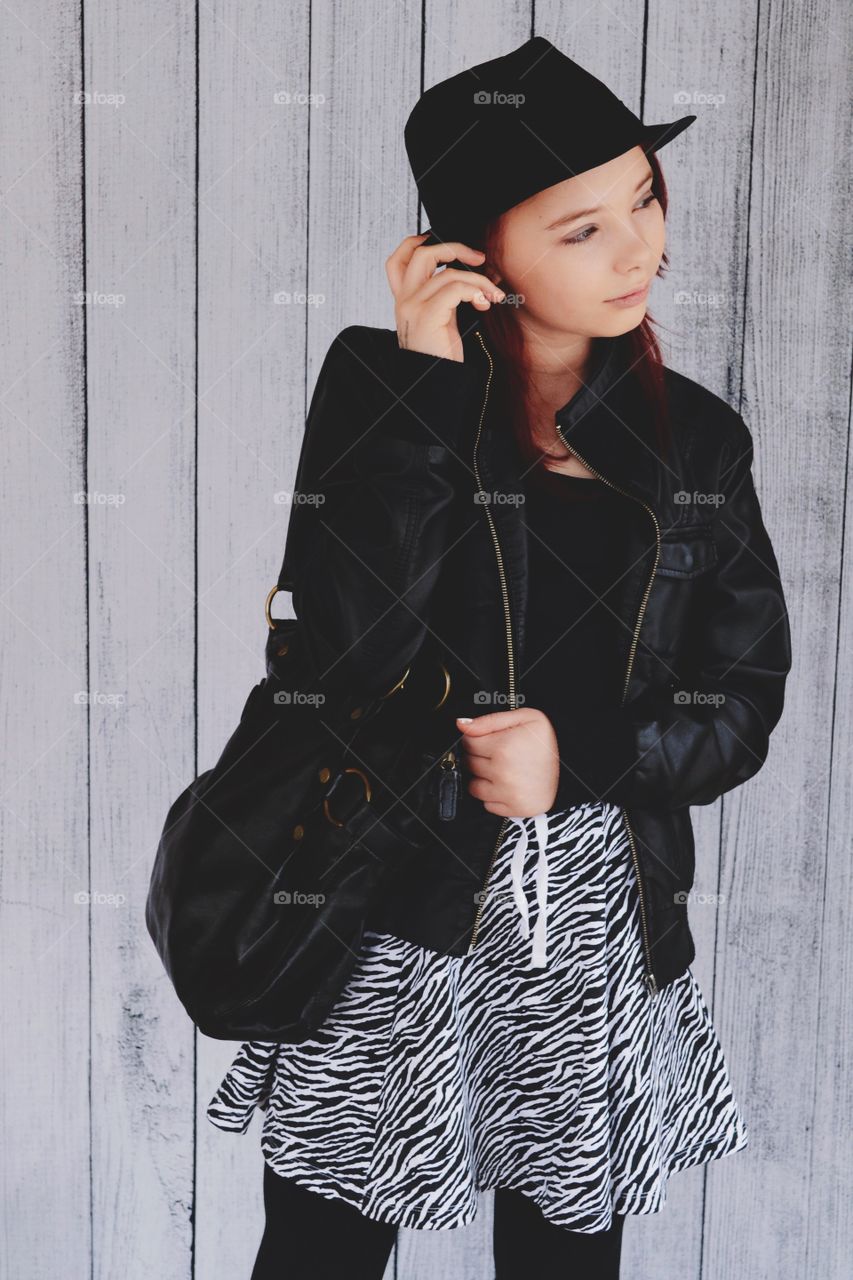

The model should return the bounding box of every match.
[251,1162,625,1280]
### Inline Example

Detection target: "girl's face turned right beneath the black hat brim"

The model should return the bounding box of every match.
[488,146,665,340]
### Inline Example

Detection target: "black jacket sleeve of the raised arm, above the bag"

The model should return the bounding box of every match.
[279,325,484,696]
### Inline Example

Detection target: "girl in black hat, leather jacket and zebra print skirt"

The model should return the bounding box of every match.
[207,38,790,1280]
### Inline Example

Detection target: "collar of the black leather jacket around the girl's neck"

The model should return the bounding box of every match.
[457,302,666,504]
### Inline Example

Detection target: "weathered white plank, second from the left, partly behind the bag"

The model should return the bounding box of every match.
[85,0,196,1280]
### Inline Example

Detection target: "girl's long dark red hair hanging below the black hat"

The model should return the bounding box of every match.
[474,151,670,472]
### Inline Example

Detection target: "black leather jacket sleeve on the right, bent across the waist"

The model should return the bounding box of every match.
[545,415,792,809]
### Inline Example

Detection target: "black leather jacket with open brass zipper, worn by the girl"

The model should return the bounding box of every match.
[279,303,792,992]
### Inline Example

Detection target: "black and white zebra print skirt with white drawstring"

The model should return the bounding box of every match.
[206,804,748,1231]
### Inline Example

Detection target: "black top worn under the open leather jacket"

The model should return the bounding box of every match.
[519,471,645,809]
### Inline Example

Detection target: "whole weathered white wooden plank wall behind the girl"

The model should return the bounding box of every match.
[0,0,853,1280]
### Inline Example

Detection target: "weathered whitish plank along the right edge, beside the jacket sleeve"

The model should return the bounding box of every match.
[706,0,853,1277]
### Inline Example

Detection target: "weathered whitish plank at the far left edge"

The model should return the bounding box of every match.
[0,6,90,1280]
